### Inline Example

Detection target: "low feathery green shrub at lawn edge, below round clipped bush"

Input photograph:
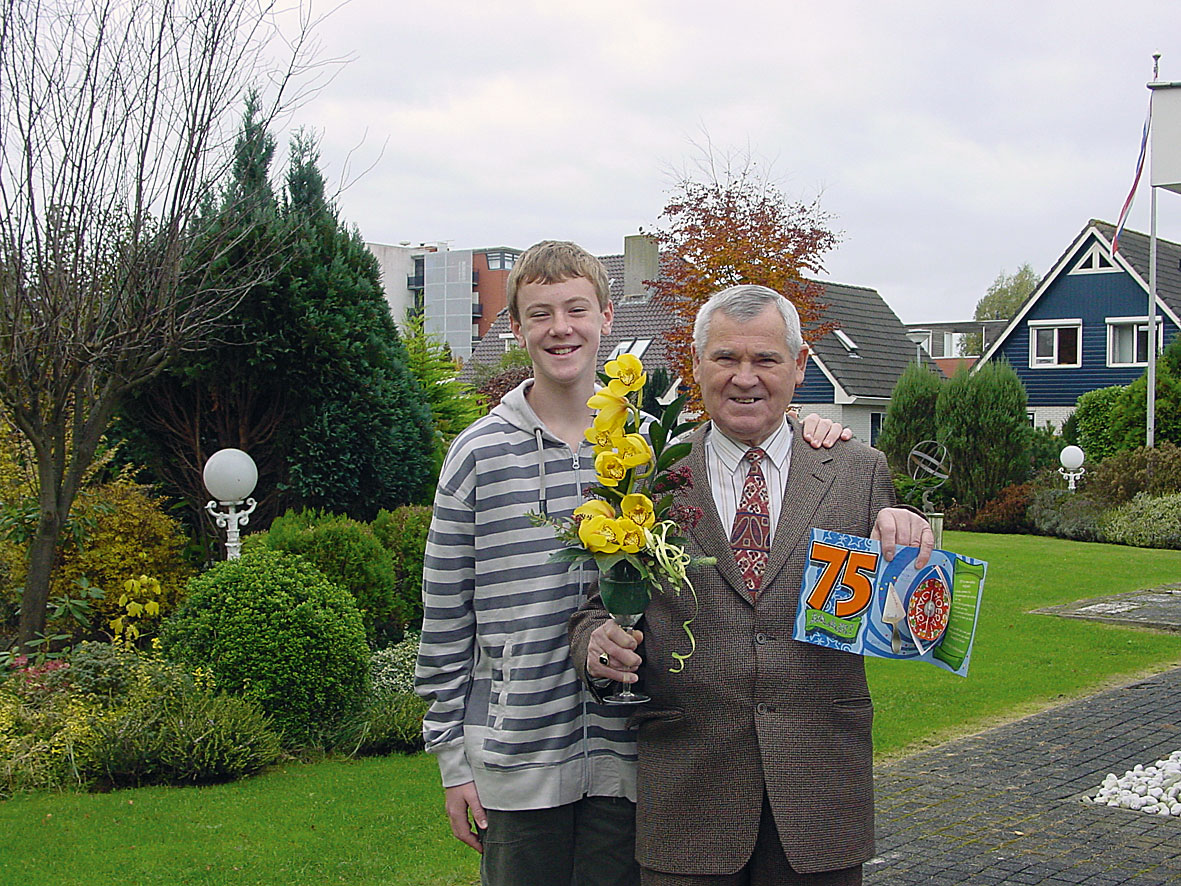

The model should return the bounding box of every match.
[89,684,281,788]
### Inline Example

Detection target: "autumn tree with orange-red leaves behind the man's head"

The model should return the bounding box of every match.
[647,164,837,415]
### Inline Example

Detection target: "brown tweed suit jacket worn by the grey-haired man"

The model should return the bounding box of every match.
[570,423,894,874]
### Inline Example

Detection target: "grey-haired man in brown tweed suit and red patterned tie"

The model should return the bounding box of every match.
[570,286,934,886]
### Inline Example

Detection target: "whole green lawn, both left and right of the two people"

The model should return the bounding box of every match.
[0,533,1181,886]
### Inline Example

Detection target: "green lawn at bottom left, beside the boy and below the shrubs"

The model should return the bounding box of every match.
[0,754,479,886]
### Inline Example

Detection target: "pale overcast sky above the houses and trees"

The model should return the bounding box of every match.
[281,0,1181,323]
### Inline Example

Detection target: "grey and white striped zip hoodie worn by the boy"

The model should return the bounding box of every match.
[415,380,635,809]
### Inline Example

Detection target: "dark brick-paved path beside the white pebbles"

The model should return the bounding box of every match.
[866,652,1181,886]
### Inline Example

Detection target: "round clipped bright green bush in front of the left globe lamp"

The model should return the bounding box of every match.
[161,549,368,747]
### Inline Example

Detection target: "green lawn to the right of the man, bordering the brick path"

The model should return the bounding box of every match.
[866,533,1181,758]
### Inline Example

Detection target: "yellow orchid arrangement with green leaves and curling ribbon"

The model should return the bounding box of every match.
[529,354,715,673]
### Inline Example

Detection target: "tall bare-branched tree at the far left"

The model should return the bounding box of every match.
[0,0,332,646]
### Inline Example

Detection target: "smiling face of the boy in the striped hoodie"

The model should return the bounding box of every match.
[510,276,613,387]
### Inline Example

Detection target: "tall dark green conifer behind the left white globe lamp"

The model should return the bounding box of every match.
[120,105,435,541]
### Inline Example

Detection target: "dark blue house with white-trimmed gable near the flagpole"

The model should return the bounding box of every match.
[980,220,1181,428]
